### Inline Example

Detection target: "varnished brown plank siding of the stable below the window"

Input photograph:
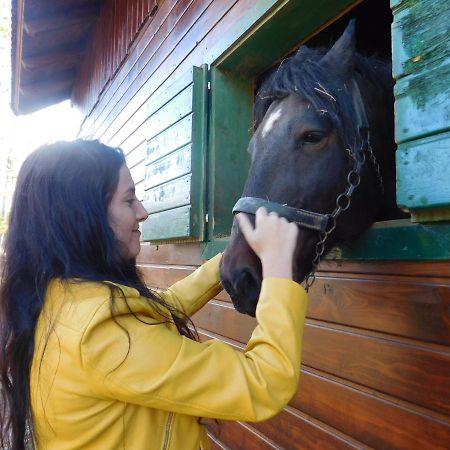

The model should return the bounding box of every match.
[139,244,450,449]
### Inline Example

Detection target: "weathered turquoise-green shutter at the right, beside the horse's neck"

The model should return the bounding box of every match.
[391,0,450,222]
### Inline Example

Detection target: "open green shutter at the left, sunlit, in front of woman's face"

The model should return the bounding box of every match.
[142,66,208,243]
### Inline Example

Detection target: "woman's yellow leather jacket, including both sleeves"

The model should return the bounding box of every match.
[30,255,307,450]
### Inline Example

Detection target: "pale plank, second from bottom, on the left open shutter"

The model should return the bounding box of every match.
[144,174,191,214]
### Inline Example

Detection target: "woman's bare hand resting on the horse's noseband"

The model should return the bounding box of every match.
[236,207,298,279]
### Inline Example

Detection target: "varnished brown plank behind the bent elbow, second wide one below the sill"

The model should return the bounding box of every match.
[195,301,450,414]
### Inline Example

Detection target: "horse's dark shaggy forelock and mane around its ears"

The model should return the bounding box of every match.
[254,46,393,148]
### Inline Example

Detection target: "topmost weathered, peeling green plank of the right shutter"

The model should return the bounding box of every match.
[391,0,450,78]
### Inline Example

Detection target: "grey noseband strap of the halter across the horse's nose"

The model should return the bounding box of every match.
[233,197,328,232]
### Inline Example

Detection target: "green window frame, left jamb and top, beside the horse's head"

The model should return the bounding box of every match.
[208,0,358,248]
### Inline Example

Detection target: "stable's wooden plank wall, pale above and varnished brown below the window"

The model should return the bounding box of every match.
[73,0,450,450]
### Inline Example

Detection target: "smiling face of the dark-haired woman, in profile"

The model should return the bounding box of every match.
[108,165,148,259]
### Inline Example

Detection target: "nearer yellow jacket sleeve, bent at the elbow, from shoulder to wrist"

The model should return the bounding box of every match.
[80,278,307,421]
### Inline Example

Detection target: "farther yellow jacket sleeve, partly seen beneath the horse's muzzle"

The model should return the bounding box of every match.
[158,253,223,317]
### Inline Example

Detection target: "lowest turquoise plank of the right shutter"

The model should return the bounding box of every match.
[396,131,450,209]
